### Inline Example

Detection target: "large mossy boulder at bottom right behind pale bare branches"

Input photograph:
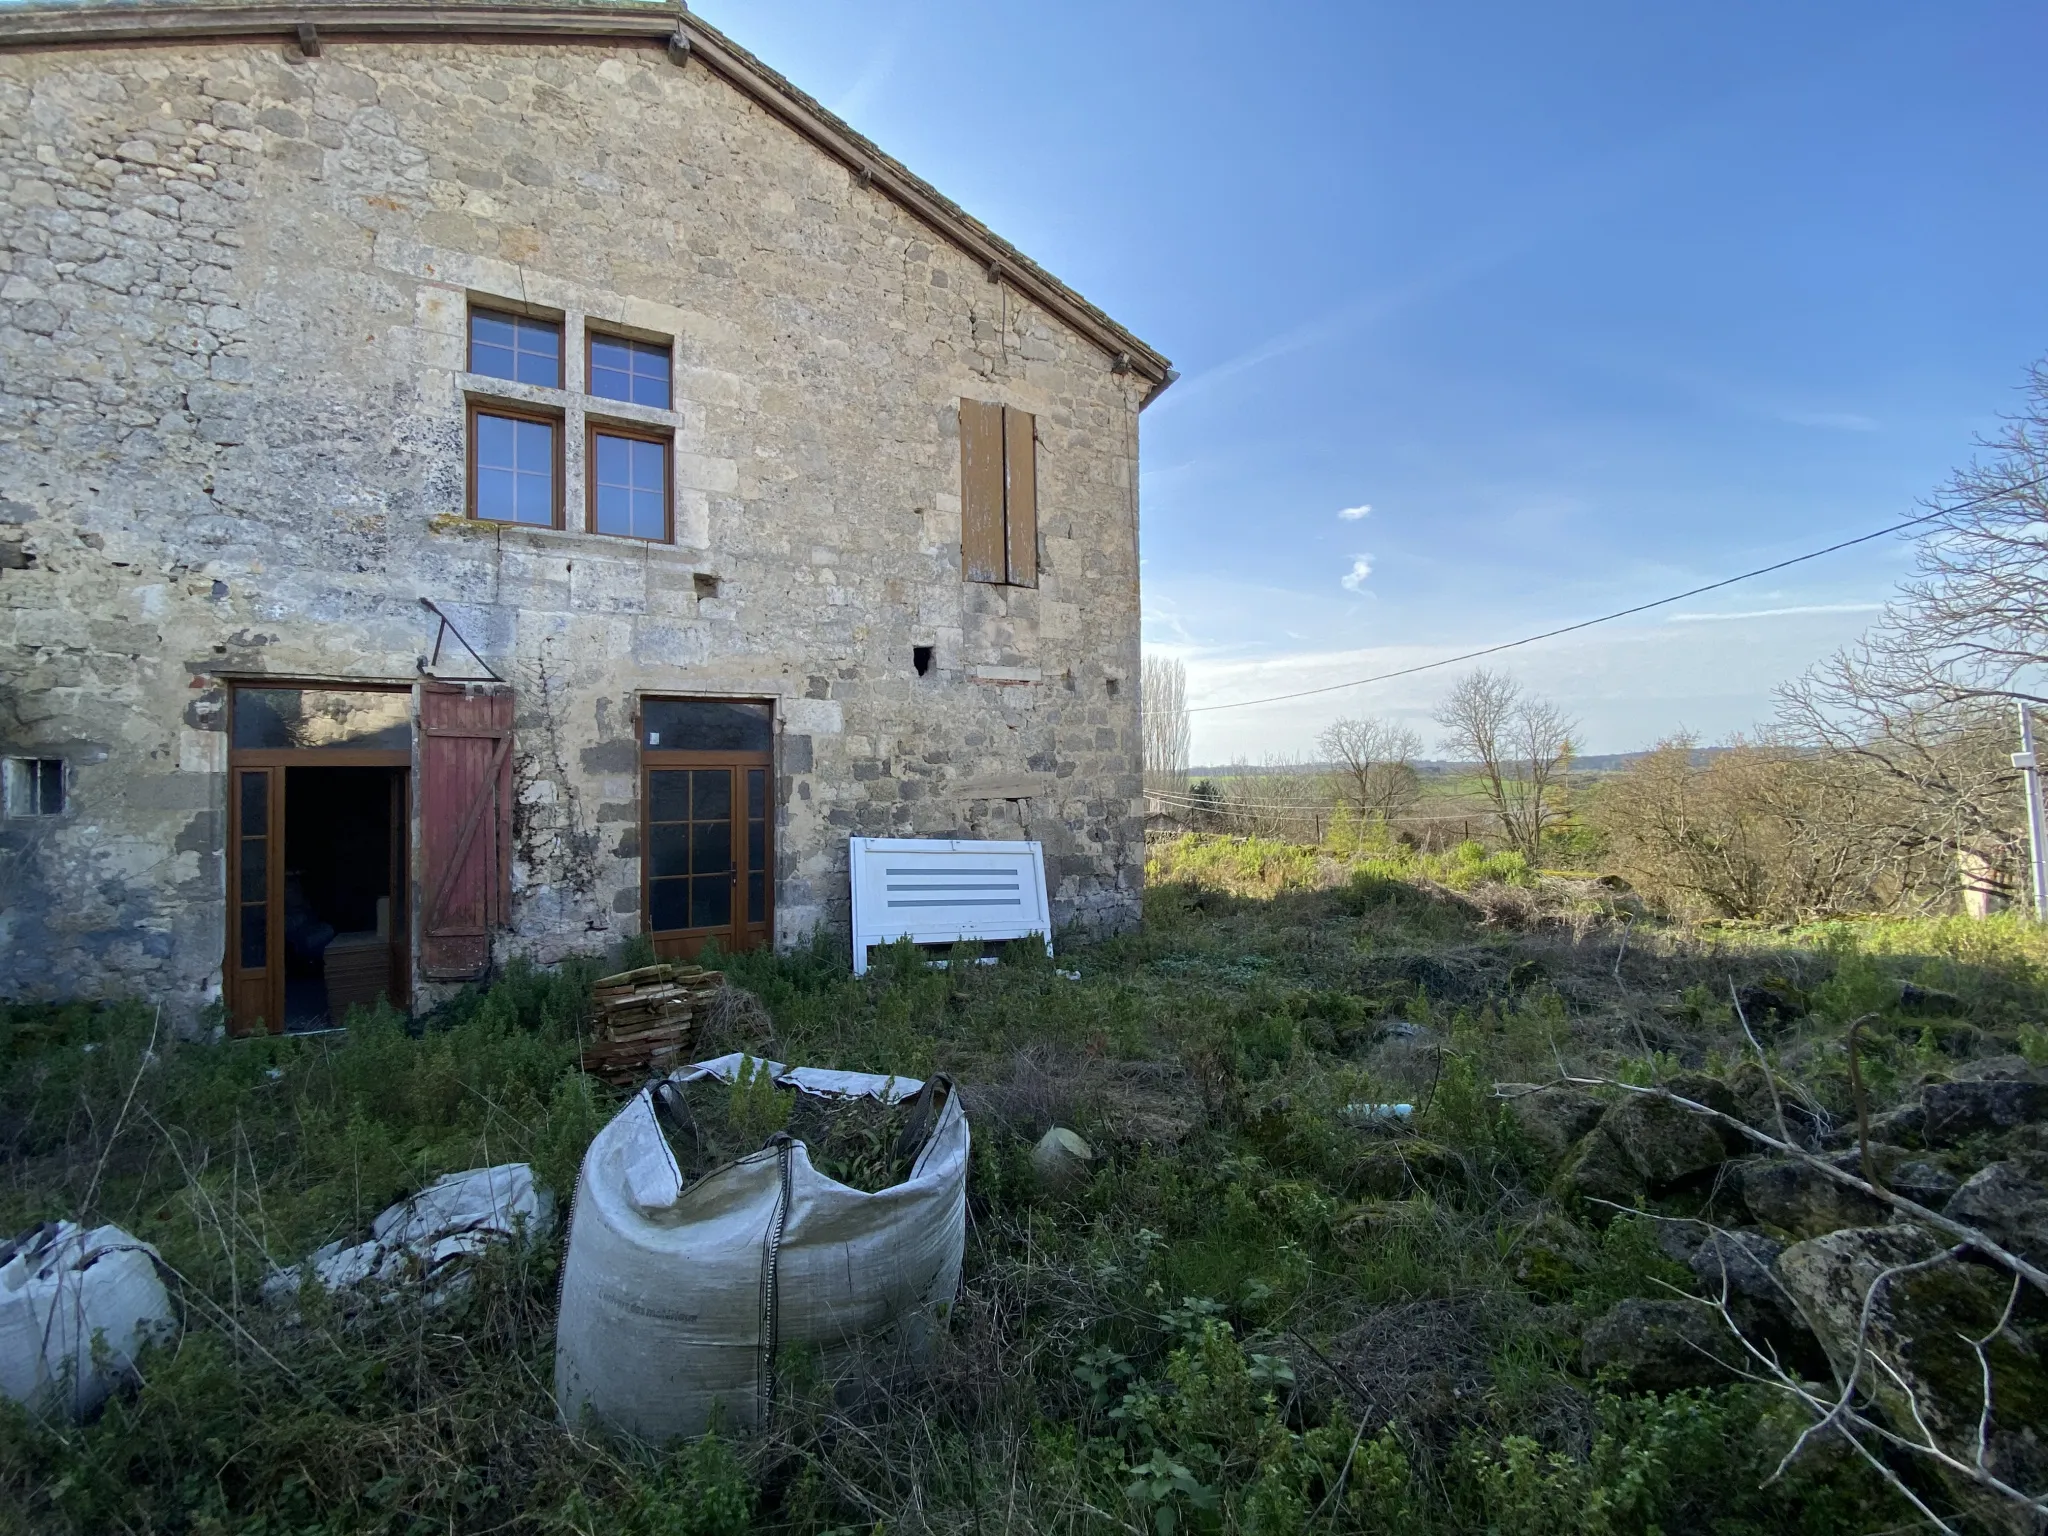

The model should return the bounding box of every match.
[1772,1223,2048,1534]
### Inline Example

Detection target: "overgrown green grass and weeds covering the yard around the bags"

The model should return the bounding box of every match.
[12,840,2048,1536]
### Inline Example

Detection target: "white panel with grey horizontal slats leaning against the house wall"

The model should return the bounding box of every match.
[848,838,1053,977]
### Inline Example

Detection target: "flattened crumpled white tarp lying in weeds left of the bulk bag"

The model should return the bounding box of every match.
[262,1163,555,1303]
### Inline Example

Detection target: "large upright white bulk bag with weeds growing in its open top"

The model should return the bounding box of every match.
[555,1055,967,1442]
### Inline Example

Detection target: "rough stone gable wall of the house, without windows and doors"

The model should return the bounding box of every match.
[0,41,1143,1024]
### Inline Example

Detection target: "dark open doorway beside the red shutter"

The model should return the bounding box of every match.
[283,768,406,1030]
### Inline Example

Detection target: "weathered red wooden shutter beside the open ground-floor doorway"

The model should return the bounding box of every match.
[420,682,512,981]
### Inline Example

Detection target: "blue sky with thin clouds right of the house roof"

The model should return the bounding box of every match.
[696,0,2048,762]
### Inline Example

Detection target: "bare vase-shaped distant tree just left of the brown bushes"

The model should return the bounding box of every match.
[1436,668,1577,864]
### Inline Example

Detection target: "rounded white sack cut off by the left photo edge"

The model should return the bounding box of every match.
[0,1221,174,1419]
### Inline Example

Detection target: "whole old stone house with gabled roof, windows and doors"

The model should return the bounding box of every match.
[0,0,1174,1030]
